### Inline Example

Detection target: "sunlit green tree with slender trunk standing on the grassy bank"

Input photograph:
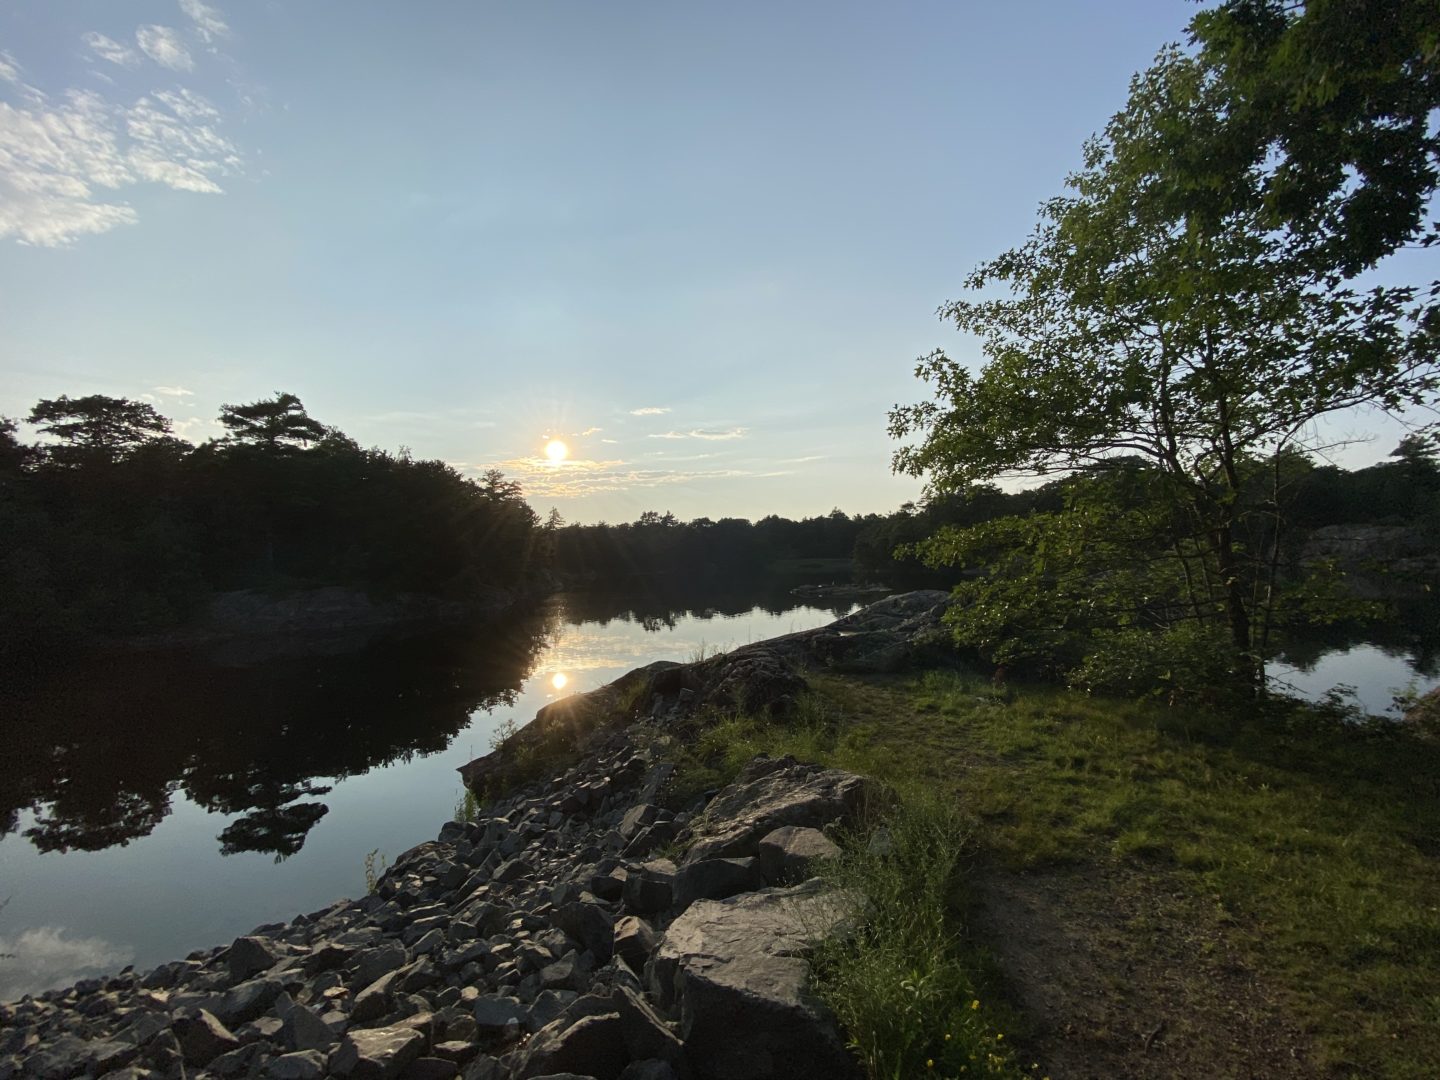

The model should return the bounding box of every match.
[890,42,1440,680]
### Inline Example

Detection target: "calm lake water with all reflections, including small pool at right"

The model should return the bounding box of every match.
[0,583,1440,999]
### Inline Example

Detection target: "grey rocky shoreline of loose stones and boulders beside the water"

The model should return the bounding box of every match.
[8,593,945,1080]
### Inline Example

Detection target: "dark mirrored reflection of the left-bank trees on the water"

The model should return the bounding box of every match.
[0,615,544,858]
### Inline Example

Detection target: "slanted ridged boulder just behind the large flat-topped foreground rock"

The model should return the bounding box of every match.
[684,757,878,865]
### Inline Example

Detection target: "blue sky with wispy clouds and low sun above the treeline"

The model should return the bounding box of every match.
[0,0,1416,521]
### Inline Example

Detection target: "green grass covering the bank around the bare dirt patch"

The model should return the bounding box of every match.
[672,672,1440,1077]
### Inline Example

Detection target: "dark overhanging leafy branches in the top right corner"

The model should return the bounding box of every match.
[1189,0,1440,274]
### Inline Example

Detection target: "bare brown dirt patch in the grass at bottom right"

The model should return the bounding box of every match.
[969,865,1320,1080]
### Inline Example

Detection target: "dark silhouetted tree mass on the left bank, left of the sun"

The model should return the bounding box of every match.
[0,393,541,659]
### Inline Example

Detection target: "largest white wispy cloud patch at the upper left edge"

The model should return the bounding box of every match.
[0,56,242,248]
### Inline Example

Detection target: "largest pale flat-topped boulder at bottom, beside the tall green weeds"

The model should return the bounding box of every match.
[651,884,857,1080]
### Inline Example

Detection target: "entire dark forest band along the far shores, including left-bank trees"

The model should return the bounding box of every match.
[0,393,1440,647]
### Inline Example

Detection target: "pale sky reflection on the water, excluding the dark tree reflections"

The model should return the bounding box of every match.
[0,596,852,999]
